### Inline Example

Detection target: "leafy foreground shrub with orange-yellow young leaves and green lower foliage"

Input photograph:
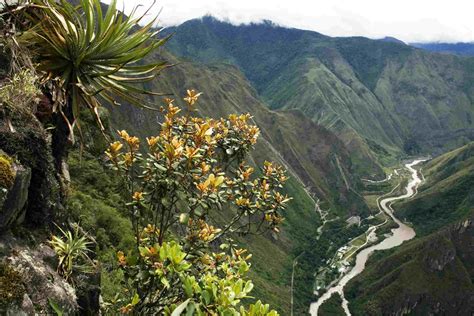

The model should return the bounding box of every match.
[106,90,289,315]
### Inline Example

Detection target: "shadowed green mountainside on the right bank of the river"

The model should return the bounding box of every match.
[346,143,474,315]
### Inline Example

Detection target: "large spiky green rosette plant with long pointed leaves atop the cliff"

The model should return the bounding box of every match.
[26,0,168,138]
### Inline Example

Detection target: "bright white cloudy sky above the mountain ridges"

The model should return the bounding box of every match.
[104,0,474,42]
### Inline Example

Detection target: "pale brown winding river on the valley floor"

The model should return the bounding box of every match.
[309,159,426,316]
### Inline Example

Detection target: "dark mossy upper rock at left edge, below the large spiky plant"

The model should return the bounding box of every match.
[0,105,62,232]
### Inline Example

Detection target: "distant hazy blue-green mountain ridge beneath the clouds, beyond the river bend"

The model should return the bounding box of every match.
[165,17,474,160]
